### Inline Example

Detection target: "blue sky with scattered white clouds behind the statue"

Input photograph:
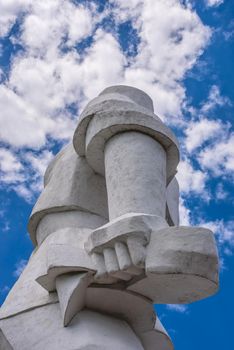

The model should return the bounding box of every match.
[0,0,234,350]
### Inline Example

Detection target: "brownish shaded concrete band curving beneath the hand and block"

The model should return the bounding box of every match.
[86,287,173,350]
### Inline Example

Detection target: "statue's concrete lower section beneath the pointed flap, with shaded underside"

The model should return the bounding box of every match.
[0,287,173,350]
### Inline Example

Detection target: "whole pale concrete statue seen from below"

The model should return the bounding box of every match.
[0,86,218,350]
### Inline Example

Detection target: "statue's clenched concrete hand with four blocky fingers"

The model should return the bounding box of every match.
[85,213,168,283]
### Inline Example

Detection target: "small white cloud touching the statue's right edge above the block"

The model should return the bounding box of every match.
[176,159,206,195]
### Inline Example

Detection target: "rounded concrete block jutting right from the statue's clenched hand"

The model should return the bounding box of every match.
[128,226,219,304]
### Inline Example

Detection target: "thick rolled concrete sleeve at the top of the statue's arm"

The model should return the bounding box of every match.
[73,86,179,183]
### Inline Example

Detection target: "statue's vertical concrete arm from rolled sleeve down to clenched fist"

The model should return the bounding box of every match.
[73,89,178,280]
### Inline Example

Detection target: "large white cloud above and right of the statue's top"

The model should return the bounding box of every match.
[121,0,211,122]
